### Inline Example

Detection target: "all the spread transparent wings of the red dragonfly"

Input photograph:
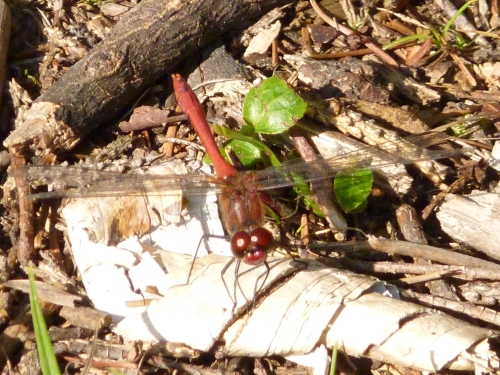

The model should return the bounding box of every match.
[11,133,463,199]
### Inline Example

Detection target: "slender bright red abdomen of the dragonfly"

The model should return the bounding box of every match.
[172,74,237,179]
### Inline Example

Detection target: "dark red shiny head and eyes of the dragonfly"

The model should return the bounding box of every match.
[231,227,274,265]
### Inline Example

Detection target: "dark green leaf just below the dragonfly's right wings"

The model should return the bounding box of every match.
[333,168,373,212]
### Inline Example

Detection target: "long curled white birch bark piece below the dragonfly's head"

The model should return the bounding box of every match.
[114,255,494,371]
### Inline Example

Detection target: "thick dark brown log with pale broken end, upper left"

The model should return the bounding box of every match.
[4,0,290,155]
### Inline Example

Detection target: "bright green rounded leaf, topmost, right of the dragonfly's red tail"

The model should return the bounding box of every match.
[243,77,307,134]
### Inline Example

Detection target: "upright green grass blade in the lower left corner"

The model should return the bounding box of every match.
[28,267,61,375]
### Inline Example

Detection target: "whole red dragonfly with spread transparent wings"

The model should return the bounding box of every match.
[12,74,462,304]
